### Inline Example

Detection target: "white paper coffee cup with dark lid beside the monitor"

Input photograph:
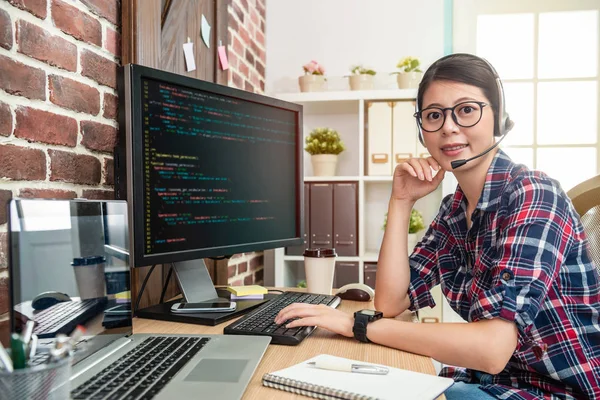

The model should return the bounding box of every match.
[304,248,337,295]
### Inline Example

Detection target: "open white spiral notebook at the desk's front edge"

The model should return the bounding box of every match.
[262,354,454,400]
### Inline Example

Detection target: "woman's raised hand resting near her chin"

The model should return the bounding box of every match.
[392,157,445,202]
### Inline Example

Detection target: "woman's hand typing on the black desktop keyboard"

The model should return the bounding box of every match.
[275,303,354,337]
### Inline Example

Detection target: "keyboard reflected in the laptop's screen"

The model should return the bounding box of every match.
[33,299,106,339]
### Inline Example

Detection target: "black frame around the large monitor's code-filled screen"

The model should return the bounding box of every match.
[115,64,306,267]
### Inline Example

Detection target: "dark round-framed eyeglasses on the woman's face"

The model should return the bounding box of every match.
[413,101,487,132]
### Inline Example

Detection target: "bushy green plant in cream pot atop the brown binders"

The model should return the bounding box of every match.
[304,128,346,176]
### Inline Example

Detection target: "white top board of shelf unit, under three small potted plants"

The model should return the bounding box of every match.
[271,89,417,103]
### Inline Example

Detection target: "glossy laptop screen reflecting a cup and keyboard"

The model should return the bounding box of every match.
[9,199,132,362]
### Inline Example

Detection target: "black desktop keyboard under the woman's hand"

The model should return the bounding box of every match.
[223,292,341,346]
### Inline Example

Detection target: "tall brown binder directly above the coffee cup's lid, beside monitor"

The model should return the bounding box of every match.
[310,183,333,248]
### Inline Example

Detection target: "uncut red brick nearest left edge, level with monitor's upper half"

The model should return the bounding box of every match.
[15,107,77,147]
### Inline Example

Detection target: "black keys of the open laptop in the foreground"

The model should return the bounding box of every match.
[71,337,210,400]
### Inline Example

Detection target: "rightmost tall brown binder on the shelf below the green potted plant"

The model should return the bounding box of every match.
[333,182,358,257]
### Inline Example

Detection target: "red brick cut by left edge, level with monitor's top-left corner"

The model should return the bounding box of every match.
[0,56,46,100]
